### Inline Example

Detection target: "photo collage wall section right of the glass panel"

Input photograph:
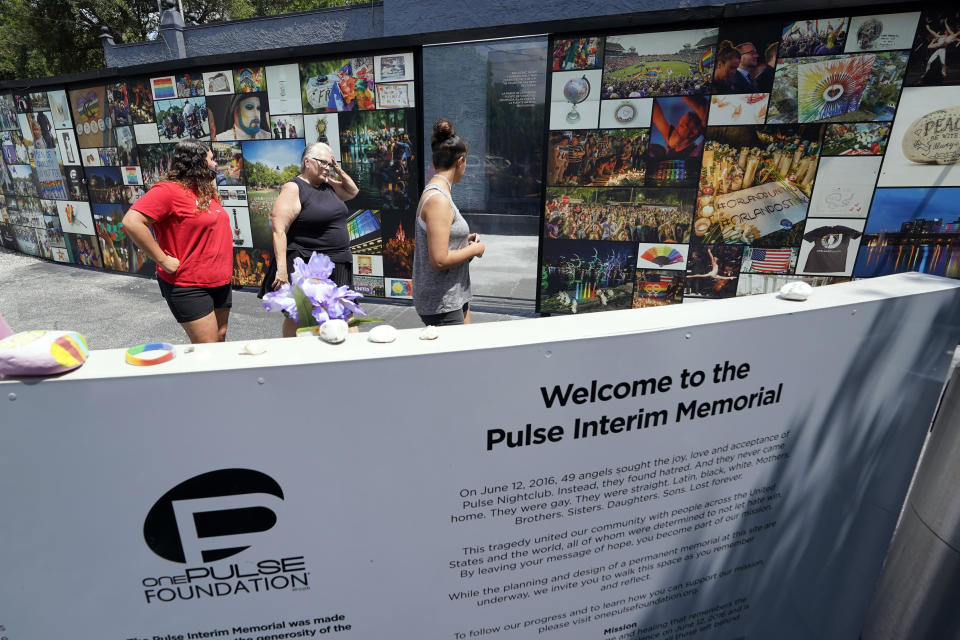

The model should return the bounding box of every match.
[537,9,960,313]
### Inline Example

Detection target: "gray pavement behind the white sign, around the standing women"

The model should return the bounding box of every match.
[0,235,537,349]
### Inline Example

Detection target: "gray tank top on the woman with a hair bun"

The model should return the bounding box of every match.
[413,184,473,315]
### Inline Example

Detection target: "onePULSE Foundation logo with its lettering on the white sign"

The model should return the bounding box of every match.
[141,469,309,603]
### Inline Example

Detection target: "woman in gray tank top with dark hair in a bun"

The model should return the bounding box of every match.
[413,118,484,326]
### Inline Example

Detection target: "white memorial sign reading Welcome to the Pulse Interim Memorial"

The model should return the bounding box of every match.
[0,274,960,640]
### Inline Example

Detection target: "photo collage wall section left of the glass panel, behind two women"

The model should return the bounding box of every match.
[0,52,420,298]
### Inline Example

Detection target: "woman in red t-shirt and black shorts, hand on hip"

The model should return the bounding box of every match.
[123,139,233,343]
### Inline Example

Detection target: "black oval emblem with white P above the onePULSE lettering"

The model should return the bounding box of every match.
[143,469,283,564]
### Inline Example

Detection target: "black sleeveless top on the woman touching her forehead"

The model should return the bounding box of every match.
[287,178,353,262]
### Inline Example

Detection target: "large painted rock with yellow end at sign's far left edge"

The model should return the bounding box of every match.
[0,331,90,376]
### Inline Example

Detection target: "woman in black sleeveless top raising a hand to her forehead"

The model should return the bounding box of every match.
[259,142,360,337]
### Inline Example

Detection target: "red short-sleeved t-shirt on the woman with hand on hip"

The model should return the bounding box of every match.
[130,182,233,287]
